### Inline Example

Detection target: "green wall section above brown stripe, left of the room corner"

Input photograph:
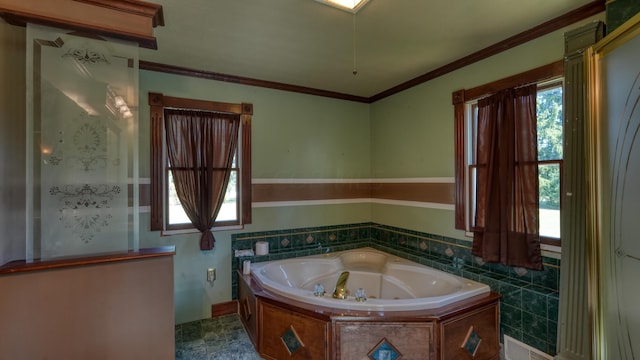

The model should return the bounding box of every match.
[140,71,371,179]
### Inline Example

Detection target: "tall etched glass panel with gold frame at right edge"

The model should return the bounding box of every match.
[591,26,640,359]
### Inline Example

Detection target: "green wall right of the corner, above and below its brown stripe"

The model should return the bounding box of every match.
[371,14,604,239]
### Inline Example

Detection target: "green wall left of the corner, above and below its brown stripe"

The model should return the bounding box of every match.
[140,71,371,323]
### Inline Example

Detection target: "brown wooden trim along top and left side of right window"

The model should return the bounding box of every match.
[451,60,564,230]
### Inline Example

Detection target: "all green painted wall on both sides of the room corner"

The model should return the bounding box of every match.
[0,11,604,323]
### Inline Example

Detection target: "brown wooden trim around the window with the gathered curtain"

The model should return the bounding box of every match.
[149,92,253,231]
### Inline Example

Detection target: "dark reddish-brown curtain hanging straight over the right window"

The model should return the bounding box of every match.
[472,85,542,270]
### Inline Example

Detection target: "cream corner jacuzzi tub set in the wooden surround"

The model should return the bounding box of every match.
[251,248,490,311]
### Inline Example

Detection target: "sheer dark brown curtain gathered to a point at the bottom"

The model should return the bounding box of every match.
[164,109,240,250]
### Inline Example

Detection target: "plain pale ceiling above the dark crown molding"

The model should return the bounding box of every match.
[140,0,592,97]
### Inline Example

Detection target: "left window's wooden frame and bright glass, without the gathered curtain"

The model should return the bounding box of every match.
[149,93,253,230]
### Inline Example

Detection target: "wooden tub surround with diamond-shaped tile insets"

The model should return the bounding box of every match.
[238,272,501,360]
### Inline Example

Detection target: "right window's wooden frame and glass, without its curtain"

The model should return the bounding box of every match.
[453,61,563,246]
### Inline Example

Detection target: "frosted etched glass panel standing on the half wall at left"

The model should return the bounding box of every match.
[27,24,138,261]
